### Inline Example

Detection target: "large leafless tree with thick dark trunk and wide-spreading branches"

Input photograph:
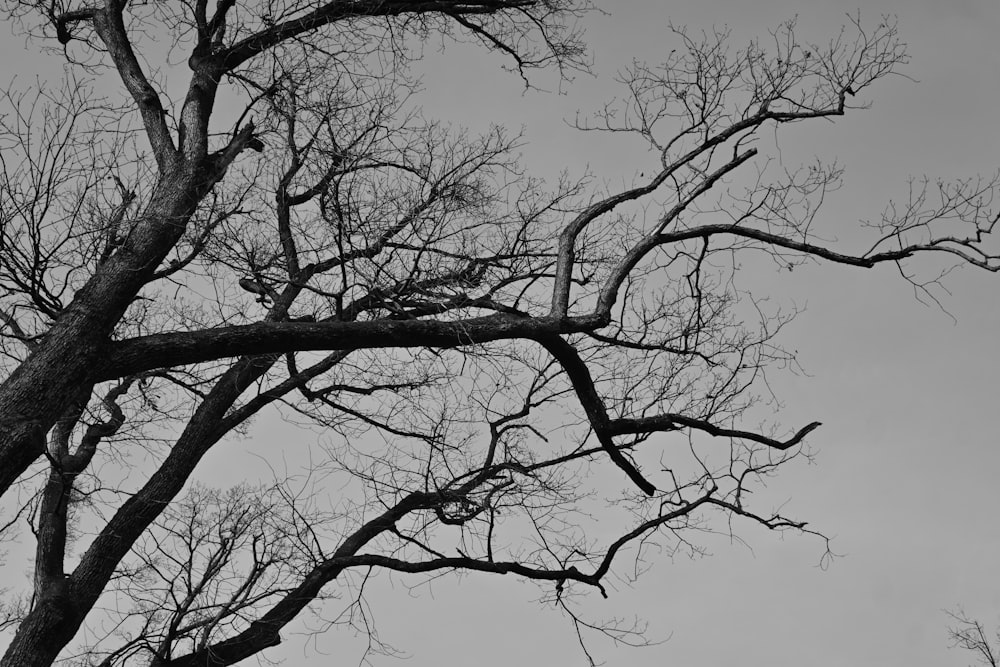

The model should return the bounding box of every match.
[0,0,1000,667]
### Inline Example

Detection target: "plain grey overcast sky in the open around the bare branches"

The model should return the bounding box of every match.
[7,0,1000,667]
